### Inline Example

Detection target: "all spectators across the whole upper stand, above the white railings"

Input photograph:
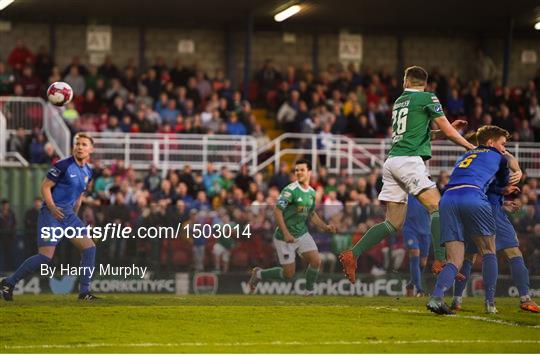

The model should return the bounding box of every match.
[0,41,540,163]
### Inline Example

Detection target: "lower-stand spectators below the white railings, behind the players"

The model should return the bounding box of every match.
[0,161,540,275]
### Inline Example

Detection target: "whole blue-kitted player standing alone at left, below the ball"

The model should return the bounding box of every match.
[0,133,97,301]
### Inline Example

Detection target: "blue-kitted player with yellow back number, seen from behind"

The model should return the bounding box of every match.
[427,126,519,314]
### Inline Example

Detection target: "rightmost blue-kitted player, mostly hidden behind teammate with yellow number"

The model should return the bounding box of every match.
[450,142,540,313]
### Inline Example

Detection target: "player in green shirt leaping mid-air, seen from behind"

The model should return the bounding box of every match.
[339,66,474,283]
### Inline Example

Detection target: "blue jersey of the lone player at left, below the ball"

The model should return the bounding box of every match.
[44,156,92,213]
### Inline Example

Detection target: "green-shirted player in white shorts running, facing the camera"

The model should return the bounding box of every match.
[249,160,336,296]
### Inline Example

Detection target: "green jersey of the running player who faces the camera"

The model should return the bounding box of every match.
[274,182,315,240]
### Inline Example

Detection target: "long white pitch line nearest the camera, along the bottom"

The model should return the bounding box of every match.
[4,339,540,350]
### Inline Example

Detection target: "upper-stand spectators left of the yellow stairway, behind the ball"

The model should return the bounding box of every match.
[0,41,264,162]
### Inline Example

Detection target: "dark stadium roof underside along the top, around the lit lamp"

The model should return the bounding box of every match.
[0,0,540,36]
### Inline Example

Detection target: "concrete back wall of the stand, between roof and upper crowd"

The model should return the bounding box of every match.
[0,23,540,85]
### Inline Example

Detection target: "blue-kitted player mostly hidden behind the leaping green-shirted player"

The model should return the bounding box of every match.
[403,195,431,297]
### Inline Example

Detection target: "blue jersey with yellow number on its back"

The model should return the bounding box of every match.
[447,146,509,192]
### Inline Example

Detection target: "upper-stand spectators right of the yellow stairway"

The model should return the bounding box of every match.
[264,52,540,142]
